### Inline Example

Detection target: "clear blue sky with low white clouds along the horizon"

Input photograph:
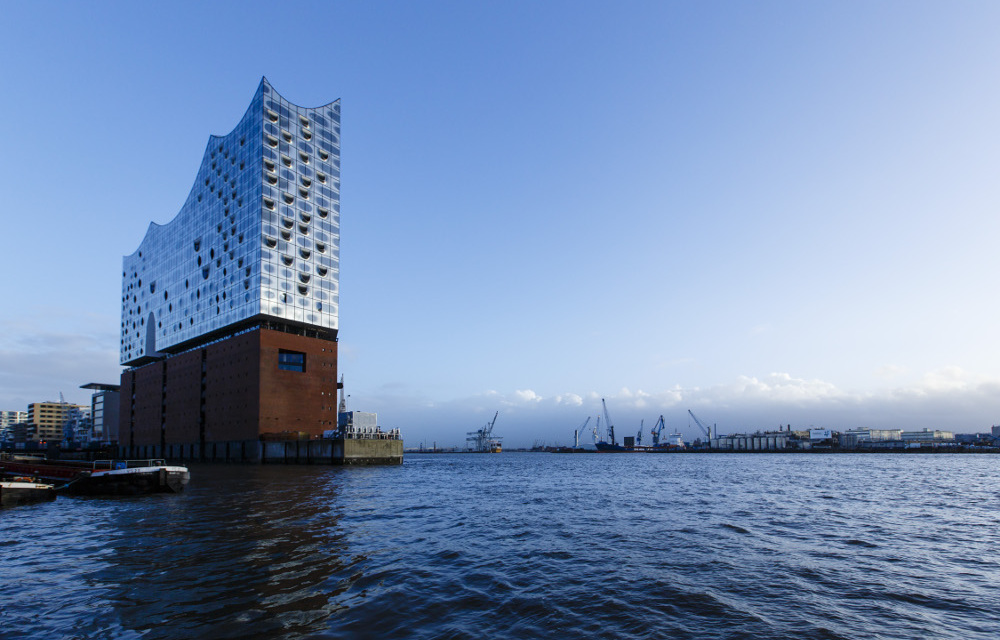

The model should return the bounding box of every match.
[0,0,1000,446]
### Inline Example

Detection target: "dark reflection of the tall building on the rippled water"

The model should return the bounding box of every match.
[101,467,353,638]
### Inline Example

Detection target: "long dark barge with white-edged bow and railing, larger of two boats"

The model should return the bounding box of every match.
[0,456,191,495]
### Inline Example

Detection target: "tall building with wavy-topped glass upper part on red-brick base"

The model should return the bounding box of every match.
[118,78,340,459]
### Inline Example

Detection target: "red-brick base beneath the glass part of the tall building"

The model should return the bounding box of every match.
[119,327,338,461]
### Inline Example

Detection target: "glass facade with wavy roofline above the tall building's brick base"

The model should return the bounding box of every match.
[120,78,340,365]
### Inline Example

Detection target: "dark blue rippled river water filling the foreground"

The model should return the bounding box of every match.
[0,453,1000,640]
